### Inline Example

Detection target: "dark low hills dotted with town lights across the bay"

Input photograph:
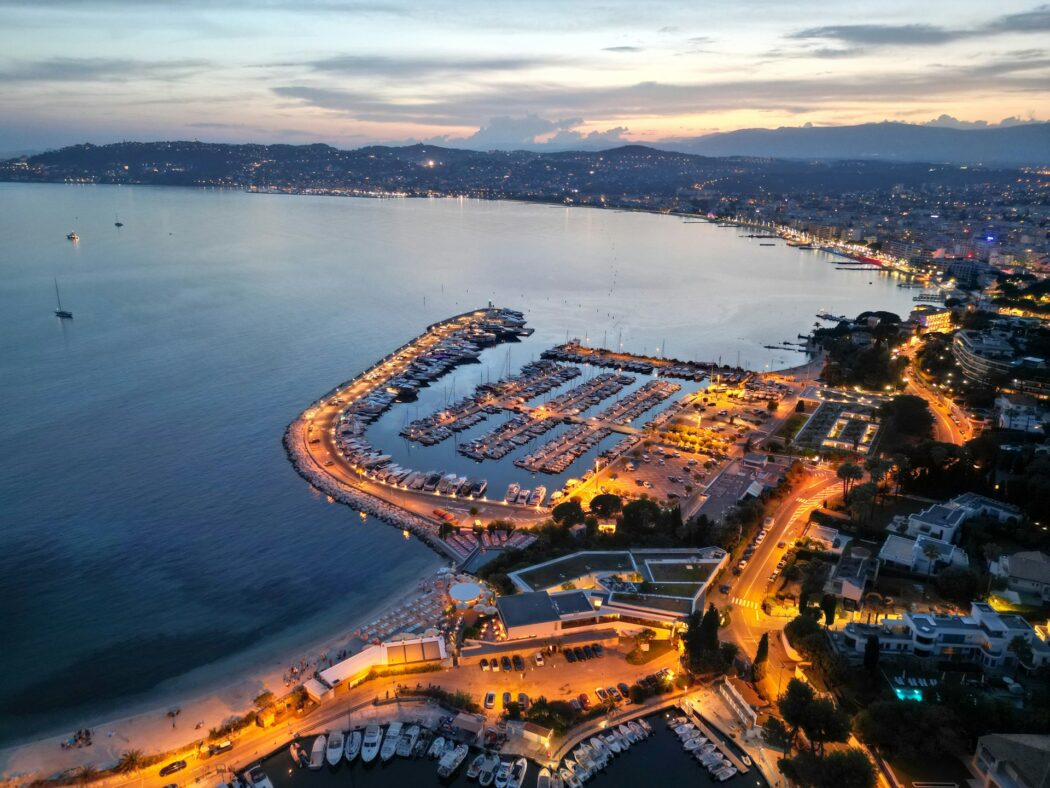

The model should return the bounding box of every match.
[0,141,1029,211]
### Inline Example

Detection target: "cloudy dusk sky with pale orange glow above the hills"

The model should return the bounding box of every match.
[0,0,1050,152]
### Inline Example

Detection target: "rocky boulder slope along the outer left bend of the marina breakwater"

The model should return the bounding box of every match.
[284,420,459,560]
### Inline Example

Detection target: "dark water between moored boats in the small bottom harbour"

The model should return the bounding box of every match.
[263,717,768,788]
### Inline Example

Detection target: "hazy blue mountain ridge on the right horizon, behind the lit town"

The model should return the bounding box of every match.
[659,123,1050,165]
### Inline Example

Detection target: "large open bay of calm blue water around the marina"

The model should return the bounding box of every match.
[0,184,911,740]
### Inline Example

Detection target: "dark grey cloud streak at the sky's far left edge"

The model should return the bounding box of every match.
[0,58,210,82]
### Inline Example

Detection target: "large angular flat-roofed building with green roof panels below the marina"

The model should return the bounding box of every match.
[485,547,729,641]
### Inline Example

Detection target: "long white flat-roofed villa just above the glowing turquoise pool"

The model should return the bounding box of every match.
[832,602,1050,670]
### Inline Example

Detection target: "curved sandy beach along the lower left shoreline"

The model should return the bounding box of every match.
[0,573,447,785]
